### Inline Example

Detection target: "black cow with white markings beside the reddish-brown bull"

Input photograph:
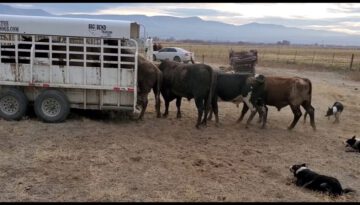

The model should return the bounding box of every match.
[209,72,266,125]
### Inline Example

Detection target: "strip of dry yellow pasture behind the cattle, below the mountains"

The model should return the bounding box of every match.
[160,42,360,71]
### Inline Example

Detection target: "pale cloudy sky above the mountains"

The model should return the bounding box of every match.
[7,3,360,35]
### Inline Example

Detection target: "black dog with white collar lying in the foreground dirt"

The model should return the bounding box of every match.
[290,164,354,196]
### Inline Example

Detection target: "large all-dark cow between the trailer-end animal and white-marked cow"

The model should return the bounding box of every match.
[159,60,216,128]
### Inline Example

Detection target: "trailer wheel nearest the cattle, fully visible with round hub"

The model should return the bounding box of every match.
[34,90,70,123]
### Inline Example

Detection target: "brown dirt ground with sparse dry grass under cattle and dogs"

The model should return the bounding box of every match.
[0,65,360,202]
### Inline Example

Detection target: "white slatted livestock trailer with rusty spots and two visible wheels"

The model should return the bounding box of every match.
[0,15,140,122]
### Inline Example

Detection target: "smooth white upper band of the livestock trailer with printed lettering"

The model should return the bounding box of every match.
[0,14,139,38]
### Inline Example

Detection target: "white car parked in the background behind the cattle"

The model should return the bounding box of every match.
[153,47,195,63]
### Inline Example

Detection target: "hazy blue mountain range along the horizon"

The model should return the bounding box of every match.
[0,4,360,46]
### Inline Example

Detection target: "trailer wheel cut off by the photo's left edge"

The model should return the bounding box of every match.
[0,88,28,120]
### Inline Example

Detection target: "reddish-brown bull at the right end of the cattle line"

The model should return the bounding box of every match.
[238,77,316,130]
